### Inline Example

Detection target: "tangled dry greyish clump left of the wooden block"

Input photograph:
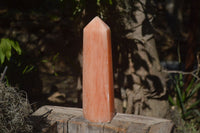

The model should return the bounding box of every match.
[0,83,33,133]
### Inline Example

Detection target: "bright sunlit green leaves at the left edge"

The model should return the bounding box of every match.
[0,38,22,64]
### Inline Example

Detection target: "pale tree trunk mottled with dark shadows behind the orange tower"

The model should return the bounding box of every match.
[112,0,169,117]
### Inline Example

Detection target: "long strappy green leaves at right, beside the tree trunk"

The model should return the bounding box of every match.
[168,74,200,120]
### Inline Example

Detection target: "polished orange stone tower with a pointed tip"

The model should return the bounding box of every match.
[83,17,115,122]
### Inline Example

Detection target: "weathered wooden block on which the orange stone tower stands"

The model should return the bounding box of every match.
[33,106,173,133]
